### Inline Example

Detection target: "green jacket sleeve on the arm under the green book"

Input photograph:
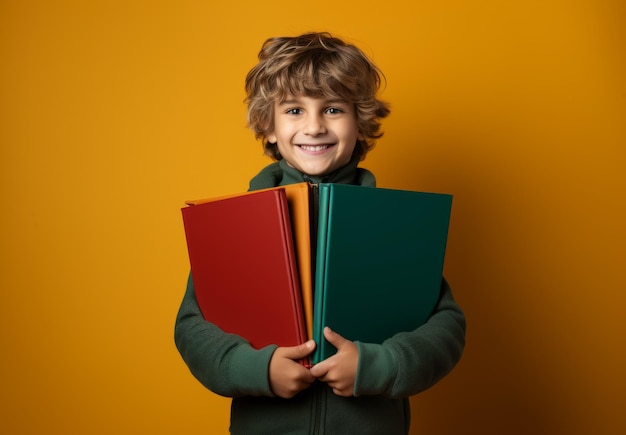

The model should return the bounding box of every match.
[354,279,466,398]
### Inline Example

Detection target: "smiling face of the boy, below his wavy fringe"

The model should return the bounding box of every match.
[266,97,363,176]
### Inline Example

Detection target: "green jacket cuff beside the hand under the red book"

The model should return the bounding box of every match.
[230,344,277,396]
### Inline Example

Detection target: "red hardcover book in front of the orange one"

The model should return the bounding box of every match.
[182,189,307,356]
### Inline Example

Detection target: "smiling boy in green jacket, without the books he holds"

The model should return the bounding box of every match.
[175,33,465,435]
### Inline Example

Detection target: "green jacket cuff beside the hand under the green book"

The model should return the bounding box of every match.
[354,341,398,396]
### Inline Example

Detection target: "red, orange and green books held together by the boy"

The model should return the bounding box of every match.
[182,183,452,364]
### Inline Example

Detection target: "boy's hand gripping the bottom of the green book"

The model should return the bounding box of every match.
[311,327,359,397]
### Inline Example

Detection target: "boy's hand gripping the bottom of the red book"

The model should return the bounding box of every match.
[269,340,315,399]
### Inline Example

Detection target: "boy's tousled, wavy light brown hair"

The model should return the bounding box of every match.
[245,32,390,160]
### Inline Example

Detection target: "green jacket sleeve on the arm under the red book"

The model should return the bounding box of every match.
[174,274,276,397]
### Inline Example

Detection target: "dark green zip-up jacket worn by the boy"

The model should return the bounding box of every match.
[174,160,465,435]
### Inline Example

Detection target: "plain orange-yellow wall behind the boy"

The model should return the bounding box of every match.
[0,0,626,435]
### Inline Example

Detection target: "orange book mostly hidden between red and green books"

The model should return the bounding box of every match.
[185,182,313,339]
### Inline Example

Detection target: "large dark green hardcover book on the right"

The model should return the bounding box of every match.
[313,183,452,364]
